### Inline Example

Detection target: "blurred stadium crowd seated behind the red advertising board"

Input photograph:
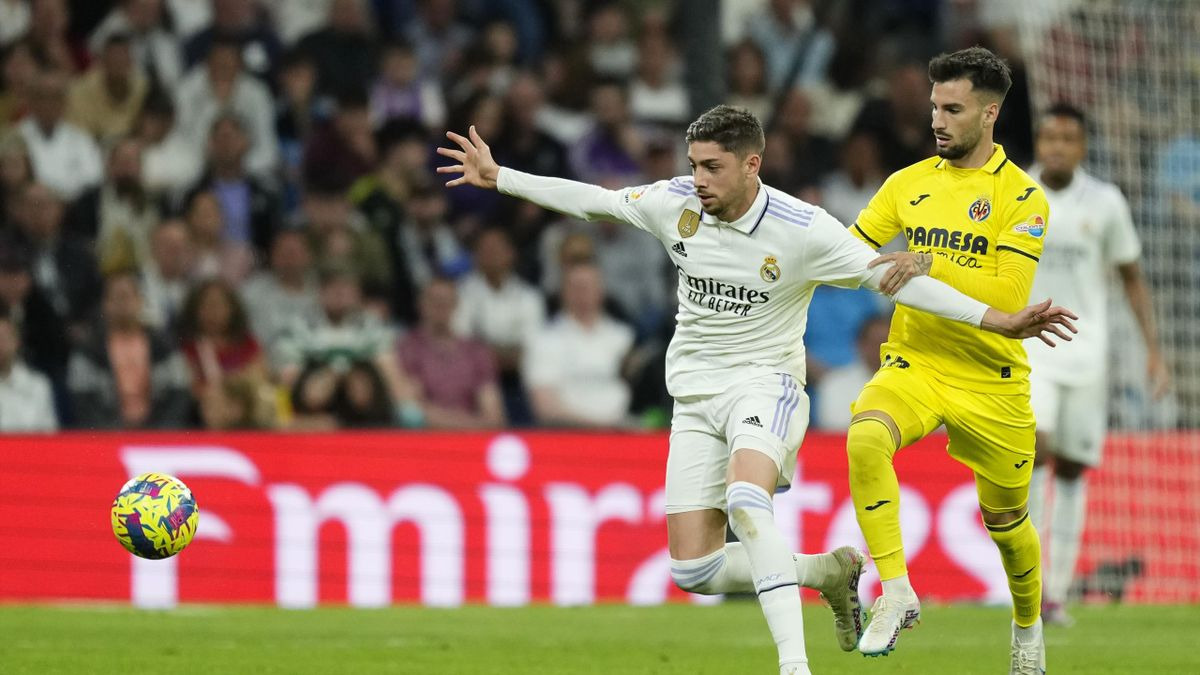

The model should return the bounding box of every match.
[0,0,1031,430]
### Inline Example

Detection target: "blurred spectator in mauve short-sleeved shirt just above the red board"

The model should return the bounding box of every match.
[400,277,505,429]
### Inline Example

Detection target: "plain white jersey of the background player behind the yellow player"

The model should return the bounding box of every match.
[1025,167,1141,384]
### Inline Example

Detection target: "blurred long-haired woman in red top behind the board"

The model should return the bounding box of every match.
[179,280,276,429]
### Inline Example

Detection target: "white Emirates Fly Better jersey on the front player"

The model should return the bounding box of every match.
[499,169,877,398]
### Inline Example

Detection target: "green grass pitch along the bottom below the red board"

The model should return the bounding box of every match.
[0,601,1200,675]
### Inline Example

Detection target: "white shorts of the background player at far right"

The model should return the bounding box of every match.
[1030,370,1109,466]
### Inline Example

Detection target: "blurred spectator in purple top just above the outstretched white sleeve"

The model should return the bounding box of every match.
[568,80,643,185]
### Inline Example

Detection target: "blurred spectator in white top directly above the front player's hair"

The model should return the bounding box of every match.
[629,34,691,125]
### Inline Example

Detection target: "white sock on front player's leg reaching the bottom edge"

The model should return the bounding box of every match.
[725,480,808,671]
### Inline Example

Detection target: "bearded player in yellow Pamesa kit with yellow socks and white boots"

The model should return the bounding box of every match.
[847,47,1050,674]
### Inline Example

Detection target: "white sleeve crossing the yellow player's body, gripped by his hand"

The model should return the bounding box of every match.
[808,211,988,325]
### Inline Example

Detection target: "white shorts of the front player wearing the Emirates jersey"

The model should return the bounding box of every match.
[666,372,809,514]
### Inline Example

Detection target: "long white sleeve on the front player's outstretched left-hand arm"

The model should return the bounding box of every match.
[496,167,665,237]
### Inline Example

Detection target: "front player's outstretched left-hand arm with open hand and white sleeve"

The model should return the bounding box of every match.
[438,126,646,228]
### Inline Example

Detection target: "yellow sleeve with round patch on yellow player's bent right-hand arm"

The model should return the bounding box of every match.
[929,191,1050,312]
